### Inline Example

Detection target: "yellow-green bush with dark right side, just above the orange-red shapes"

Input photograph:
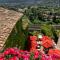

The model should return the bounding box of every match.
[41,24,58,43]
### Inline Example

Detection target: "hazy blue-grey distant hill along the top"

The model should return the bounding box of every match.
[0,0,60,6]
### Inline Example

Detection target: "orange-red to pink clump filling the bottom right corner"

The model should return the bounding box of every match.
[48,49,60,60]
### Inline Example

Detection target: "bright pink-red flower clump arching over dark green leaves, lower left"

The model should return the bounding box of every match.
[4,48,21,59]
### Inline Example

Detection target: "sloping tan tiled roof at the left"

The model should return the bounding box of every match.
[0,7,23,49]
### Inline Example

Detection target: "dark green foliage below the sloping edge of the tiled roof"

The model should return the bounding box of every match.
[4,18,28,49]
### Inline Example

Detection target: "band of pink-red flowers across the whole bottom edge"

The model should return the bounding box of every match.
[0,48,60,60]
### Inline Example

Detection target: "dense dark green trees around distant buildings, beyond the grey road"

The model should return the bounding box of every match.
[24,7,60,24]
